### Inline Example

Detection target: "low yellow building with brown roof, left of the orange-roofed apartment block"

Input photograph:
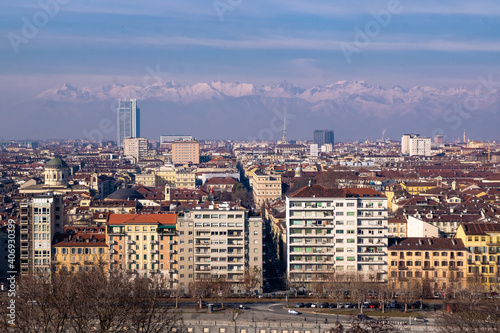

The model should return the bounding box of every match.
[52,226,108,272]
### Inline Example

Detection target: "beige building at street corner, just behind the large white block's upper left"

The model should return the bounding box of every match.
[251,170,281,207]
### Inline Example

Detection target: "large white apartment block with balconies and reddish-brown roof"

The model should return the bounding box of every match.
[286,185,387,286]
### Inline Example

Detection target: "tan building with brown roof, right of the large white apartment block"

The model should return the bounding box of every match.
[388,237,467,297]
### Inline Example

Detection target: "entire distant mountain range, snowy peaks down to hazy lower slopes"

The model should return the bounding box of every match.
[24,81,500,140]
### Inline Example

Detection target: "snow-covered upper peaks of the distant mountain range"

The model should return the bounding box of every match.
[37,81,498,105]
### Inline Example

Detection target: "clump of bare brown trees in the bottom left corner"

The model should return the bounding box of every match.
[0,267,182,333]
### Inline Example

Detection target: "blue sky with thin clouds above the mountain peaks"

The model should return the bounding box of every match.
[0,0,500,100]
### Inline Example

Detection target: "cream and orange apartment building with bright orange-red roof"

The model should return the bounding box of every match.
[106,214,177,288]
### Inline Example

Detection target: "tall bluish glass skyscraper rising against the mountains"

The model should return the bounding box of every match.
[117,99,141,147]
